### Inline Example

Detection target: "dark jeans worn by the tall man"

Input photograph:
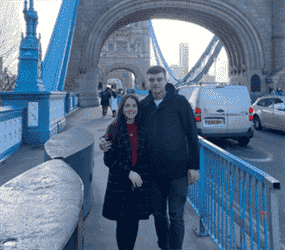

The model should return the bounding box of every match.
[151,176,188,250]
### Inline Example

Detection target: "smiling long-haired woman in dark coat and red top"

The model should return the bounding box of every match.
[102,94,152,250]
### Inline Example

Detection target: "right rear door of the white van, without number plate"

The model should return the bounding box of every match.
[226,86,252,133]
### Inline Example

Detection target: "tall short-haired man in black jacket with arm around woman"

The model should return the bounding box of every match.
[99,66,200,249]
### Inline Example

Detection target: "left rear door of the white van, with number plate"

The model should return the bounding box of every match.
[198,86,228,136]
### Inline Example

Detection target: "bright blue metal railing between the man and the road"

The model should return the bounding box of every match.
[187,136,280,250]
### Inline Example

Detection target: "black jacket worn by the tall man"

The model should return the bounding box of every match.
[138,83,200,179]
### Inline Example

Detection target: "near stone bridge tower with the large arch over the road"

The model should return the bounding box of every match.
[64,0,285,107]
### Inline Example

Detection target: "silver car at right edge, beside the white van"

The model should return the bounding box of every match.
[252,95,285,131]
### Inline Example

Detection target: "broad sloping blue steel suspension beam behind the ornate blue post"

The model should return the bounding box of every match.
[42,0,78,91]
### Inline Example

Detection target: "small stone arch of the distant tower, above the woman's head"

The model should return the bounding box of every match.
[98,63,146,88]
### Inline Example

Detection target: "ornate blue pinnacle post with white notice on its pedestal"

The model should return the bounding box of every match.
[0,0,54,145]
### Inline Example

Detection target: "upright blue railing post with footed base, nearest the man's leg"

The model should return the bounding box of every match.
[194,145,208,237]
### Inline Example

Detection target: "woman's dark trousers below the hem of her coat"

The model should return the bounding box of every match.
[116,217,139,250]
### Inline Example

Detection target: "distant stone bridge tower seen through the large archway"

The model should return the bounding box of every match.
[97,21,150,89]
